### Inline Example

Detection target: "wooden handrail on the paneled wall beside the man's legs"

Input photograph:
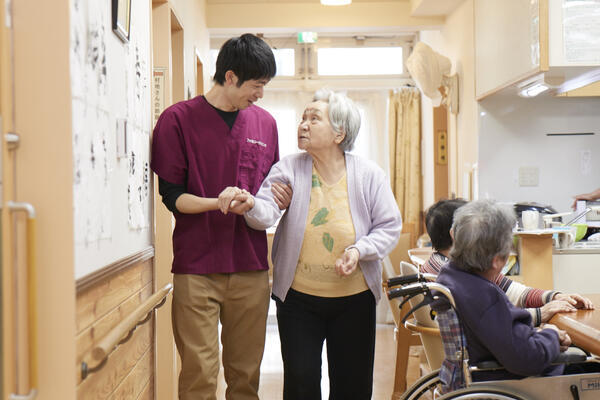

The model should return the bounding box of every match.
[82,283,173,379]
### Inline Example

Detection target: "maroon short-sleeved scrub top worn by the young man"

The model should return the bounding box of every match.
[150,96,279,274]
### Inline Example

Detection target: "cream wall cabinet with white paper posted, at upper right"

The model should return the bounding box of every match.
[474,0,600,100]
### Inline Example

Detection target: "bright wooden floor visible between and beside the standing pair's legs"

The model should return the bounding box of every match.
[217,318,420,400]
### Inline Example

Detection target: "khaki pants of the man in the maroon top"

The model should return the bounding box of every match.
[173,271,269,400]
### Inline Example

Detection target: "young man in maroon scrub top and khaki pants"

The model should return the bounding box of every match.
[151,34,282,400]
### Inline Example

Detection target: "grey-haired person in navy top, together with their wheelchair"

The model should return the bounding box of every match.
[388,201,600,399]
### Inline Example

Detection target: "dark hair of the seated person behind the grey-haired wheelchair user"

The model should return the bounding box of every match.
[425,199,467,250]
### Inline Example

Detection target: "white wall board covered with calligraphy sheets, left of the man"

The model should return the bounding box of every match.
[70,0,152,279]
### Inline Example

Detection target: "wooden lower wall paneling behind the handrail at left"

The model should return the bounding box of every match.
[76,252,155,400]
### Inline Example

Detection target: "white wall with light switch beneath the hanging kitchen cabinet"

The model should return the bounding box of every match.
[479,95,600,212]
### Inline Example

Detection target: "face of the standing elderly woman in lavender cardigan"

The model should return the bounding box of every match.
[298,101,344,153]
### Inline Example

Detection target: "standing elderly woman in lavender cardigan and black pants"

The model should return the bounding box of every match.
[225,90,402,400]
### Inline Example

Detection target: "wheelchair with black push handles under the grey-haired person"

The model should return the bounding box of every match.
[387,273,600,400]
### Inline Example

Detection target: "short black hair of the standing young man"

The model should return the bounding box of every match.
[213,33,277,87]
